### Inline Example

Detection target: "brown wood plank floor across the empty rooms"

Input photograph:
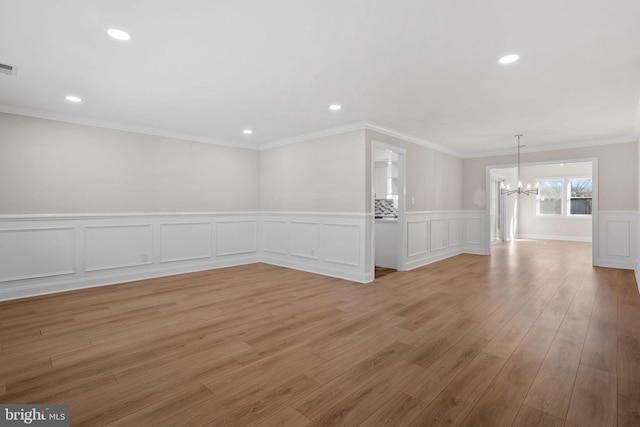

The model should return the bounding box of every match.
[0,240,640,426]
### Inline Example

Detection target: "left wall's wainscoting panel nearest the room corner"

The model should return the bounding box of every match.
[216,219,258,256]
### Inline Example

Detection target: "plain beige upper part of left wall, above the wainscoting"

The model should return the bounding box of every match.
[0,113,260,215]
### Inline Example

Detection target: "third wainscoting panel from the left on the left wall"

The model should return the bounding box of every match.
[160,222,212,262]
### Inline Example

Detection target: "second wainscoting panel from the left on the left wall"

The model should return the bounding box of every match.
[84,224,153,271]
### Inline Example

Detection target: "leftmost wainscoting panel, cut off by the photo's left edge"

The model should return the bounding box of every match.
[0,227,75,282]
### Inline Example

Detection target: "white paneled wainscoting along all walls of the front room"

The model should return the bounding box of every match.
[0,211,640,300]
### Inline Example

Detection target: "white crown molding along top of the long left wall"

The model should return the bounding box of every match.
[0,104,257,150]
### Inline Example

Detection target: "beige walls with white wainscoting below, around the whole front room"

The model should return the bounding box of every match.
[0,114,638,299]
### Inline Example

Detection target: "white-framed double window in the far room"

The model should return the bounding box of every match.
[536,177,593,216]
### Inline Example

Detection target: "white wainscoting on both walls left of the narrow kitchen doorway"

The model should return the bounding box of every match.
[0,212,373,300]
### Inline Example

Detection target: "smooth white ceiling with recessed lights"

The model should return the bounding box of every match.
[0,0,640,155]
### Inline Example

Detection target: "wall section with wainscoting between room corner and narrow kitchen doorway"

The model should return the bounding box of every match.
[260,130,373,282]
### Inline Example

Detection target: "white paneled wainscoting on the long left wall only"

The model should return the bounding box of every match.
[0,212,260,300]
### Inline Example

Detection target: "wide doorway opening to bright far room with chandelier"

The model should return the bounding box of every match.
[486,158,598,265]
